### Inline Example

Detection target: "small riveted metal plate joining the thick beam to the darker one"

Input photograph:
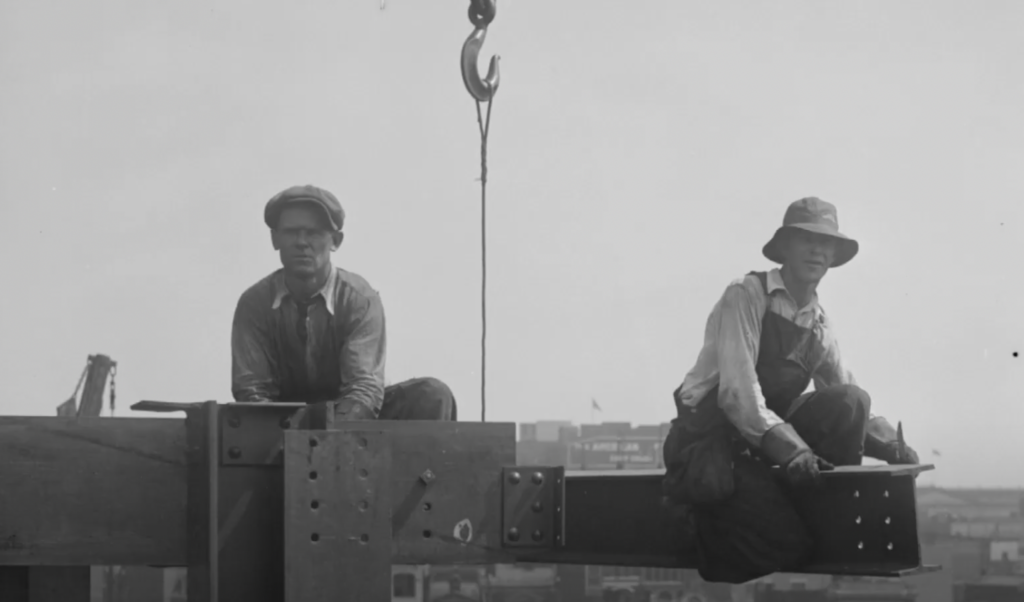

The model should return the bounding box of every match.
[502,466,565,549]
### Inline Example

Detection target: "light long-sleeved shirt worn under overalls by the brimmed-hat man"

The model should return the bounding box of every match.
[679,268,856,446]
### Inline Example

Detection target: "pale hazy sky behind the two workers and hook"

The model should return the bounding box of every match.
[0,0,1024,487]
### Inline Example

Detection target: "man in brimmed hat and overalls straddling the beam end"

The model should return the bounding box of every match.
[663,197,918,583]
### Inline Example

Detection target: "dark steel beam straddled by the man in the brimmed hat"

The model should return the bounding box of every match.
[506,466,937,576]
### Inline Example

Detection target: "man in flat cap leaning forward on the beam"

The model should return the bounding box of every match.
[231,185,457,421]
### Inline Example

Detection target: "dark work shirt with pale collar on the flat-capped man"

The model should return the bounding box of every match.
[231,267,387,415]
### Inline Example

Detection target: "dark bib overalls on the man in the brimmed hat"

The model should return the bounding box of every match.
[663,272,866,583]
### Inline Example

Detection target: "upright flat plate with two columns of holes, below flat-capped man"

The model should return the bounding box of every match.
[285,430,392,602]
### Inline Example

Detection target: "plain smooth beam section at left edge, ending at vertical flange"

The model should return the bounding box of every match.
[0,417,187,566]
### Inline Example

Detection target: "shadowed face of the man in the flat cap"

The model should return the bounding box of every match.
[271,205,341,276]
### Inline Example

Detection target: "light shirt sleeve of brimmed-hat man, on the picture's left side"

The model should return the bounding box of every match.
[717,283,783,446]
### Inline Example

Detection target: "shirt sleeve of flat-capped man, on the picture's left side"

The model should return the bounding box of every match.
[231,295,281,402]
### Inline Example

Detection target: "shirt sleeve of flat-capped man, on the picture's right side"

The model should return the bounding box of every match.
[338,293,387,416]
